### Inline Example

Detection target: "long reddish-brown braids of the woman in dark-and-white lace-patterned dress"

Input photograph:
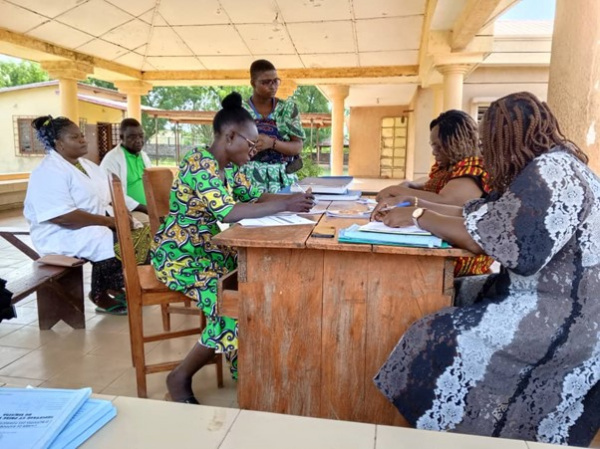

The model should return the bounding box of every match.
[481,92,588,193]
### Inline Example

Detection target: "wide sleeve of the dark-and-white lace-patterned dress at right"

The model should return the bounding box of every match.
[464,152,590,276]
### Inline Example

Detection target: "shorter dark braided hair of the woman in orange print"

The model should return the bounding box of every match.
[429,109,481,165]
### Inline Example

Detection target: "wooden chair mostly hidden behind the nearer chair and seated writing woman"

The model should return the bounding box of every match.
[142,167,197,331]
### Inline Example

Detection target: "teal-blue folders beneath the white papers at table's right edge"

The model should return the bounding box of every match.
[338,224,450,248]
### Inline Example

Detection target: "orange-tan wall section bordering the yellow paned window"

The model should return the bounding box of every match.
[348,106,410,178]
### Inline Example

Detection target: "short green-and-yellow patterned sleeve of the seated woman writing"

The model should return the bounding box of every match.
[187,155,235,221]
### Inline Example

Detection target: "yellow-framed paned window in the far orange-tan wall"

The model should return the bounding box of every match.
[379,117,408,179]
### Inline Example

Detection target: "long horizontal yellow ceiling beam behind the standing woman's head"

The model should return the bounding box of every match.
[143,65,418,84]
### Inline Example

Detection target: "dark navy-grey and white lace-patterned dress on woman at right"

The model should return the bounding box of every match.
[375,149,600,446]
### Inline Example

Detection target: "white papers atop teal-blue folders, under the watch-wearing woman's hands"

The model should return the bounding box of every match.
[338,221,450,248]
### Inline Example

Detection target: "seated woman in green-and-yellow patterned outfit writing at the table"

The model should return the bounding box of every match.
[152,92,314,404]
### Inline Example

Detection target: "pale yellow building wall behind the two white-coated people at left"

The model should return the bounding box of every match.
[0,86,123,173]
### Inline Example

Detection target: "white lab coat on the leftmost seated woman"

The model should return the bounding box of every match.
[24,151,115,262]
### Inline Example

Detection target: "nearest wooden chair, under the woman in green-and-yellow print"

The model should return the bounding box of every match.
[111,175,223,398]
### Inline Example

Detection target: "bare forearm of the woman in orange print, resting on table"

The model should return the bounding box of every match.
[377,177,483,206]
